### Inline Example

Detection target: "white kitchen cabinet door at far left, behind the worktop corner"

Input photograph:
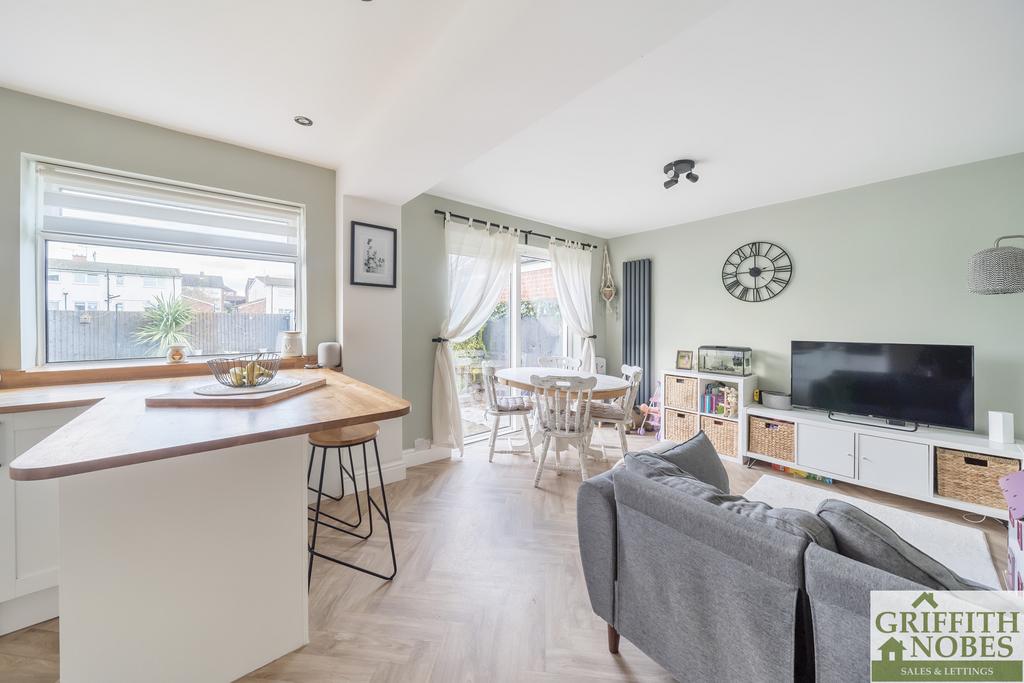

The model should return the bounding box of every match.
[0,408,86,599]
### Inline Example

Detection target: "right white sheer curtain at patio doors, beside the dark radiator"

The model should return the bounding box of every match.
[548,240,597,373]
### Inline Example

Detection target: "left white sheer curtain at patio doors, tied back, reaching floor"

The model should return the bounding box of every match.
[431,217,519,452]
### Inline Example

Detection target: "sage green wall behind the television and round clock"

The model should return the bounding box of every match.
[605,155,1024,434]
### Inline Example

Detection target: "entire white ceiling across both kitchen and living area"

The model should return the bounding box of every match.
[0,0,1024,236]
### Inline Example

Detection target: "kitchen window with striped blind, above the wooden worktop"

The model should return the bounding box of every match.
[35,162,303,362]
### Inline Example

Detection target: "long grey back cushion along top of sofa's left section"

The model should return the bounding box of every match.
[624,453,836,550]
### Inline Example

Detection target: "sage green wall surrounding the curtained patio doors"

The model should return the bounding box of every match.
[401,195,604,449]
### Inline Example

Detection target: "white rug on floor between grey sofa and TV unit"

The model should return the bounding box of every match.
[743,474,999,588]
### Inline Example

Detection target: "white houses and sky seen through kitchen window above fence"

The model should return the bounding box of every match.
[46,256,295,315]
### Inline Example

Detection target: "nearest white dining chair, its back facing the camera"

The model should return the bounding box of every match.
[529,375,597,486]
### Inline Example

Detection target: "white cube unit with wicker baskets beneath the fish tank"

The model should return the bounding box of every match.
[662,370,758,462]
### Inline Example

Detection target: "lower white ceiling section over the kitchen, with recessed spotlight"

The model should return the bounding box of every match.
[0,0,718,204]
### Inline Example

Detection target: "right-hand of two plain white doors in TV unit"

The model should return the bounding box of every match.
[857,434,929,497]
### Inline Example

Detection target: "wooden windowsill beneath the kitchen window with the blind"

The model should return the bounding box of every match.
[0,355,316,389]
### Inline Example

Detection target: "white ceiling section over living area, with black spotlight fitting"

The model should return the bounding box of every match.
[433,0,1024,237]
